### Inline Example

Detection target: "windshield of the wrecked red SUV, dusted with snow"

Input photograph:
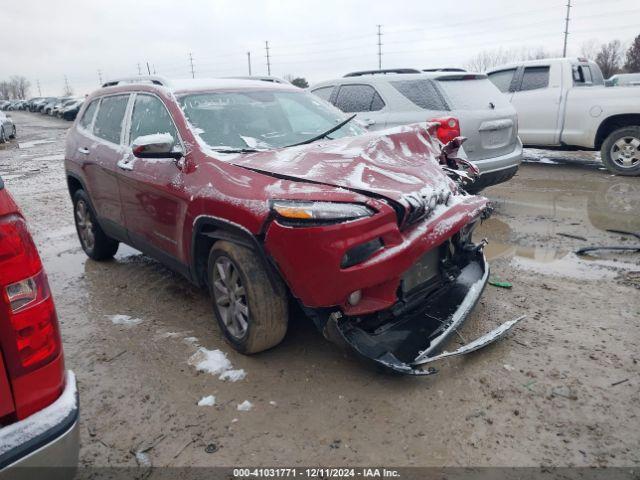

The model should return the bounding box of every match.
[179,90,364,150]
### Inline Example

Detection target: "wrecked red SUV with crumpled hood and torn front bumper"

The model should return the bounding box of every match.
[65,77,520,374]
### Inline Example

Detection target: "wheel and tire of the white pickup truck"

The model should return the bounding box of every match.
[600,126,640,176]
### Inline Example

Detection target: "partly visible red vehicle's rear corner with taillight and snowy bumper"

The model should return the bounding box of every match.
[0,174,79,479]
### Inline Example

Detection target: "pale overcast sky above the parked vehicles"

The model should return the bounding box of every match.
[0,0,640,95]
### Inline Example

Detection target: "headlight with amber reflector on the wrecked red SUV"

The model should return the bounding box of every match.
[271,200,375,224]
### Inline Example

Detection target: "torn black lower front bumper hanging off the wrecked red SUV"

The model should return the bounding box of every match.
[323,214,523,375]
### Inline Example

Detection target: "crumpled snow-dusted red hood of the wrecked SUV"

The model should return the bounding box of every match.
[230,124,455,207]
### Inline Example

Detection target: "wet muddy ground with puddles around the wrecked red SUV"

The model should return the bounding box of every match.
[0,112,640,466]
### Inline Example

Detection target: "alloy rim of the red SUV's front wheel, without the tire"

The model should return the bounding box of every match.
[213,256,249,339]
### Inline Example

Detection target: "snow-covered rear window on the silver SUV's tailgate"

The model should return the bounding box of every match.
[438,77,509,110]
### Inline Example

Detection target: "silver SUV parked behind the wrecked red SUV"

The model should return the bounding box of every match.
[310,69,522,191]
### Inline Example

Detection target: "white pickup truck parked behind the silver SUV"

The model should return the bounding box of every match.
[487,58,640,175]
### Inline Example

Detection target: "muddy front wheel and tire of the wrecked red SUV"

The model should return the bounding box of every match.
[207,241,289,355]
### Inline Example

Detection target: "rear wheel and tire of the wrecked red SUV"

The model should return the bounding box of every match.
[73,190,119,261]
